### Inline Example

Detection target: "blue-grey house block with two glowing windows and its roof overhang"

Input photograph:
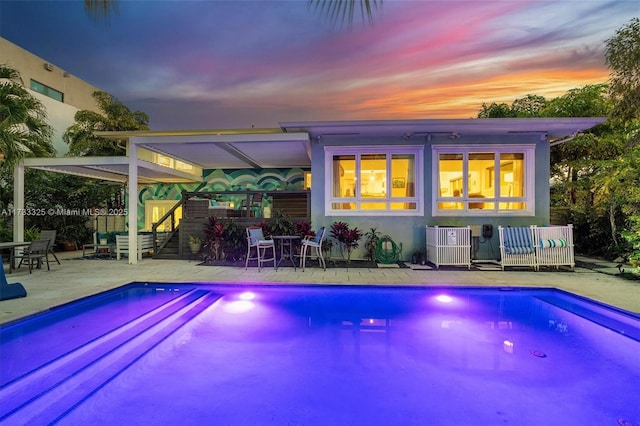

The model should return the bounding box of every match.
[280,118,604,260]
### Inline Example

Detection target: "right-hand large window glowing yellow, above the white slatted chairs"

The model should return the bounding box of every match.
[433,145,535,216]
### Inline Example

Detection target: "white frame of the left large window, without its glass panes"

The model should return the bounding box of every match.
[324,145,424,216]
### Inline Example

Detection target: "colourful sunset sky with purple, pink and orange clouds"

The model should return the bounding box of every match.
[0,0,640,130]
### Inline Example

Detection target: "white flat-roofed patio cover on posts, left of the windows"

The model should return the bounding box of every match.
[13,129,311,263]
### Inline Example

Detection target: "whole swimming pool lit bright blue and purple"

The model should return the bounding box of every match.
[0,283,640,425]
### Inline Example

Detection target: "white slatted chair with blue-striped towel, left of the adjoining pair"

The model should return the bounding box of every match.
[498,226,538,271]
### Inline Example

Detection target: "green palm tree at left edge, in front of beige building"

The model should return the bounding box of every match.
[0,65,55,169]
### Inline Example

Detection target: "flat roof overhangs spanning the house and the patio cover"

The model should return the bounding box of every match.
[23,117,606,184]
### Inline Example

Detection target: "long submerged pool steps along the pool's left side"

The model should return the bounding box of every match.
[0,290,220,425]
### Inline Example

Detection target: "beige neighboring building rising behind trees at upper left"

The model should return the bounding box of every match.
[0,37,100,156]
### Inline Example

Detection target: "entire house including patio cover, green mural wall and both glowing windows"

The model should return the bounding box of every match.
[15,118,605,262]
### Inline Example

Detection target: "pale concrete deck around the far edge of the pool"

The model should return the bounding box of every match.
[0,251,640,324]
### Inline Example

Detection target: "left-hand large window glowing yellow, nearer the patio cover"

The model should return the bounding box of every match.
[325,147,424,216]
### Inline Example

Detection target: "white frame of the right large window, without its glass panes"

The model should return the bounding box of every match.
[431,144,536,217]
